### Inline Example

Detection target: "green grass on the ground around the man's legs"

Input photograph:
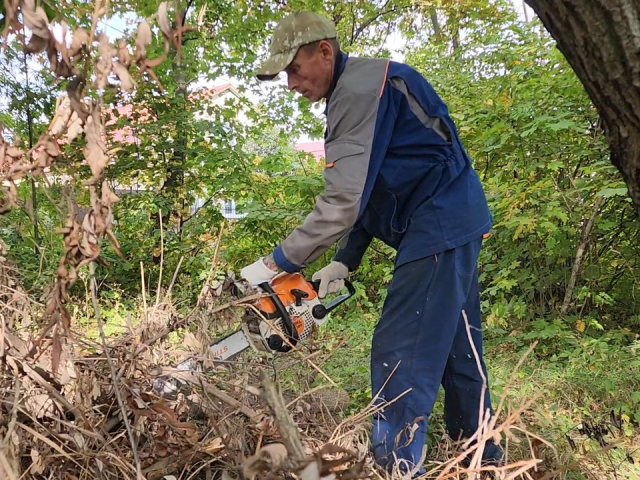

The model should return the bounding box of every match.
[319,316,640,480]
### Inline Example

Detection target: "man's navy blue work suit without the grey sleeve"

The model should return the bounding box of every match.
[328,51,502,473]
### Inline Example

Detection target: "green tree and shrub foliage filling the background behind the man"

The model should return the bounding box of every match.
[2,0,640,336]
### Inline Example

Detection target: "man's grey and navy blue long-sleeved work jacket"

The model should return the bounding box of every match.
[273,52,492,272]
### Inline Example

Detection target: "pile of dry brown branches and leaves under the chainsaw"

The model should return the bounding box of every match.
[0,258,367,480]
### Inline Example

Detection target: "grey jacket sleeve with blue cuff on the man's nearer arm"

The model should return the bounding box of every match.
[273,91,380,272]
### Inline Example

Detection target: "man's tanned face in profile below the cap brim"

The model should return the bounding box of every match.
[284,40,334,102]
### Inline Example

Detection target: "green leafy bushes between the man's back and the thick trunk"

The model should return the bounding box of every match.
[402,12,639,334]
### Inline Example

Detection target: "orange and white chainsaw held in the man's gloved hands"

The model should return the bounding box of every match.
[154,273,356,394]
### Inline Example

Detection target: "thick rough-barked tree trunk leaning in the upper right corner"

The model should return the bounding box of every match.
[526,0,640,213]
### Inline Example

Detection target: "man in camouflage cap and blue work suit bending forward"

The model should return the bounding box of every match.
[241,12,501,473]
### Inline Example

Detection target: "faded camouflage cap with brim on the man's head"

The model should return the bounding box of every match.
[256,12,337,80]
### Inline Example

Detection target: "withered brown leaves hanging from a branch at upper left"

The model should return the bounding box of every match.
[0,0,191,366]
